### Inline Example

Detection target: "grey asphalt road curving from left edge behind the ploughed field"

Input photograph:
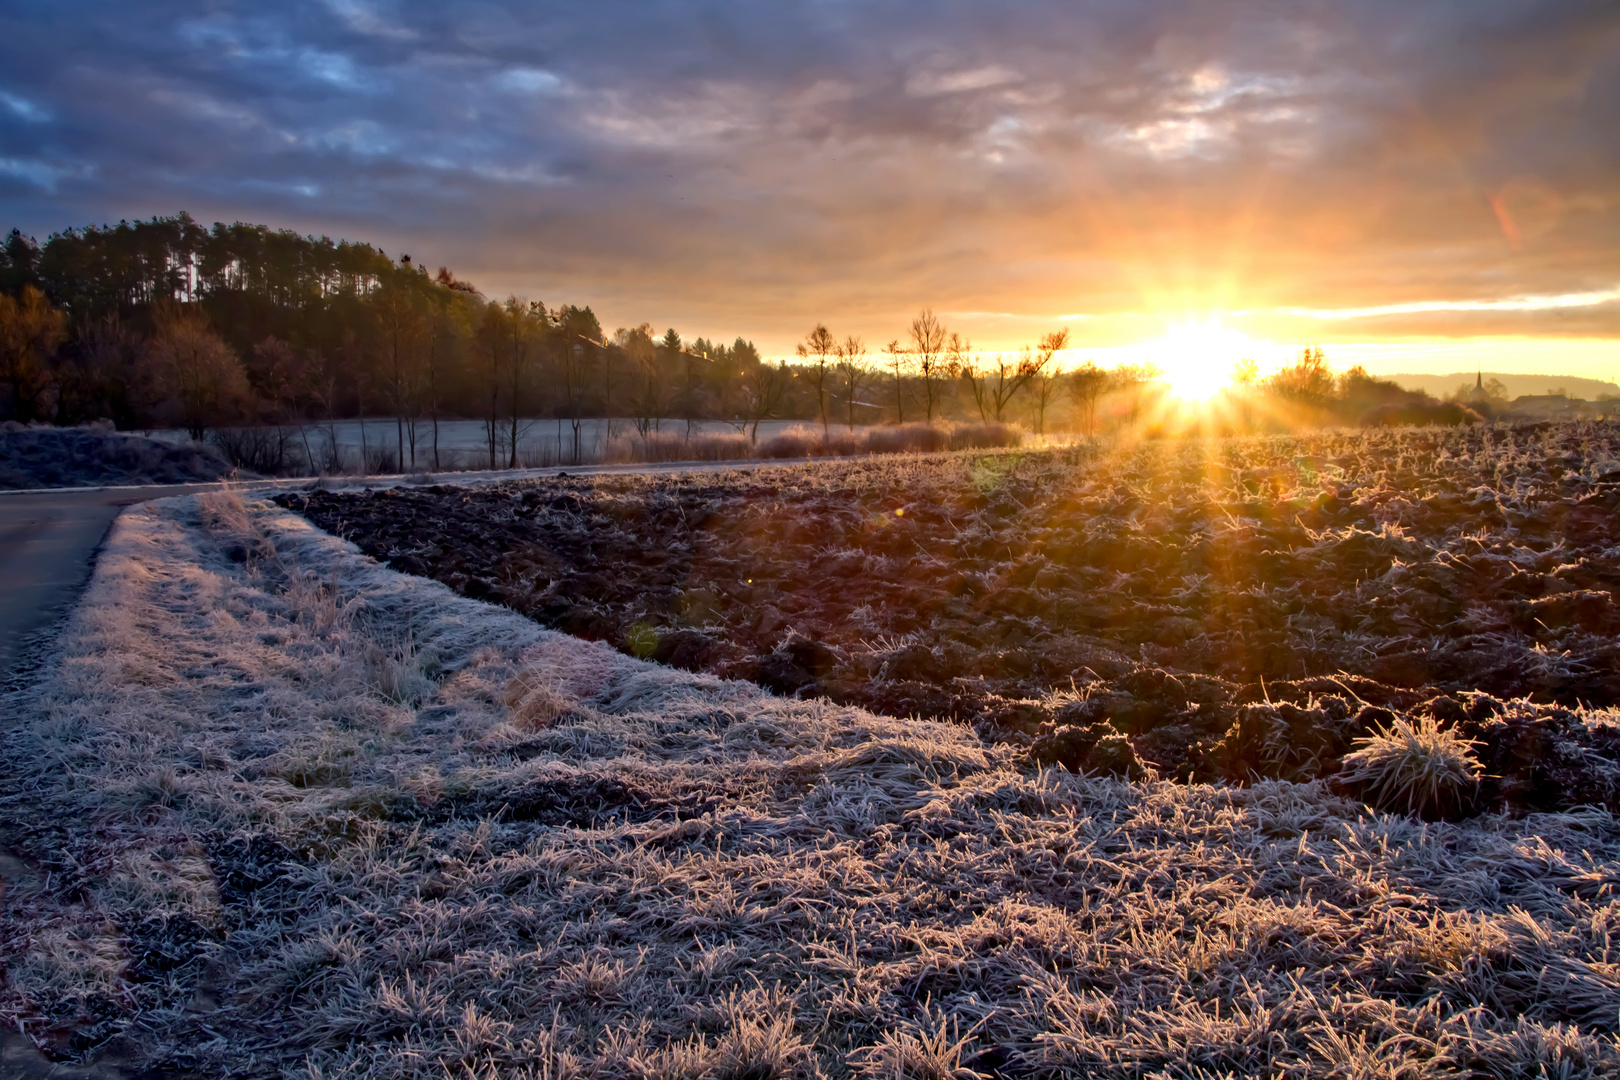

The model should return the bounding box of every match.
[0,460,822,685]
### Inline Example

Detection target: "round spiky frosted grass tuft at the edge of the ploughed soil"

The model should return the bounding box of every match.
[1338,716,1482,819]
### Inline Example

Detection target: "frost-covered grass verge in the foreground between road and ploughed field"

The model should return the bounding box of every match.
[0,495,1620,1080]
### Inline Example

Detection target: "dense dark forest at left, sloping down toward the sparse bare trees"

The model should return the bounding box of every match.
[0,214,787,466]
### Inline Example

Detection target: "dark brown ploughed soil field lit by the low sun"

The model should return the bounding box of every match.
[284,423,1620,806]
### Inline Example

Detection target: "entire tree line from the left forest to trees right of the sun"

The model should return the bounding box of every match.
[0,214,1445,468]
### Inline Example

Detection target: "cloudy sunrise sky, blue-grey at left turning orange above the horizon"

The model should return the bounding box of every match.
[0,0,1620,377]
